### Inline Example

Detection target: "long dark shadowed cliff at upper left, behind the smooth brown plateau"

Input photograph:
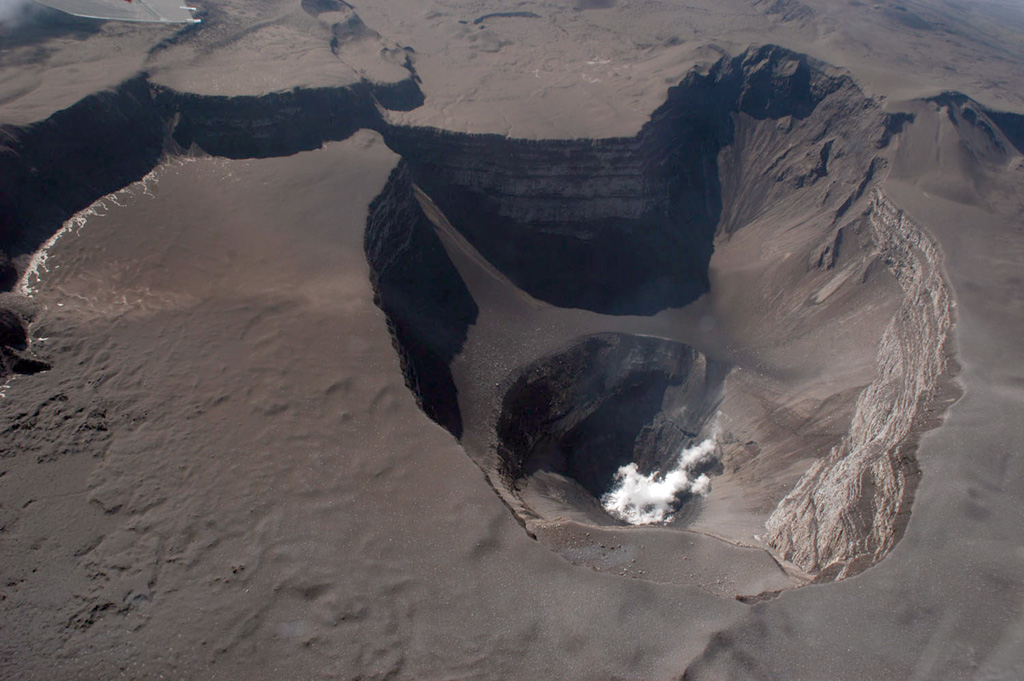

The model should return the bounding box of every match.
[0,75,423,255]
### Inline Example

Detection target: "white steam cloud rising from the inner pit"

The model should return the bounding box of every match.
[601,436,716,525]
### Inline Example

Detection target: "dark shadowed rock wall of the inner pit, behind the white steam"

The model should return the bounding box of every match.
[497,334,725,509]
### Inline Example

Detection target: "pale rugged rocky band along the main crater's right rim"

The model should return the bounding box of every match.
[765,189,954,580]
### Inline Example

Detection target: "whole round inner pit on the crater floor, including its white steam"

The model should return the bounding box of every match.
[496,334,727,524]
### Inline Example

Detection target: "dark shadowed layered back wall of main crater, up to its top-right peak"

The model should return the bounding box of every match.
[385,47,868,314]
